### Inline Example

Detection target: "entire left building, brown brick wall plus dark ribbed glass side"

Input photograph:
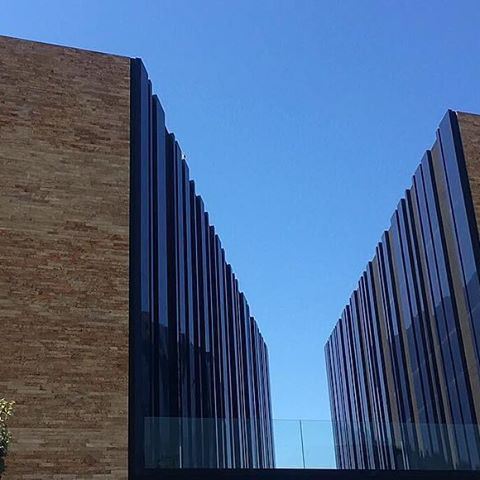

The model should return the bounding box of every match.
[0,37,274,480]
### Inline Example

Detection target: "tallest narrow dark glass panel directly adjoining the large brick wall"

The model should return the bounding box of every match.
[129,59,153,474]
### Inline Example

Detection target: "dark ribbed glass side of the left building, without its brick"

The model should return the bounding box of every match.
[129,60,275,475]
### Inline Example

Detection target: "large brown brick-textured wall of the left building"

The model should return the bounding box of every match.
[0,37,130,480]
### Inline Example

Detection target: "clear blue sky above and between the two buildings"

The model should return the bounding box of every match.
[0,0,480,419]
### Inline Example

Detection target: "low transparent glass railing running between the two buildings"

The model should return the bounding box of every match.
[143,417,480,470]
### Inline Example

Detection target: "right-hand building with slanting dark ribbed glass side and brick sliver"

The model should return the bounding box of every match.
[325,111,480,469]
